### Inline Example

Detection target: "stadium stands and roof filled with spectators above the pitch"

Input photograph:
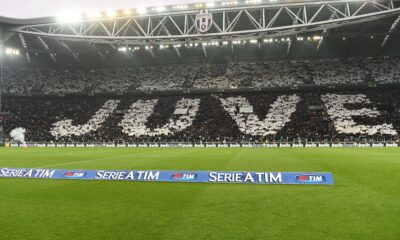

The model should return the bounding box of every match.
[0,1,400,143]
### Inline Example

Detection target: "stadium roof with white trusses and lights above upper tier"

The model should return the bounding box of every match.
[0,0,400,67]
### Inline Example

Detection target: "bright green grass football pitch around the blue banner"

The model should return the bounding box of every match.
[0,148,400,240]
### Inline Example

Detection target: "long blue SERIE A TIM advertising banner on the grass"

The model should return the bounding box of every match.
[0,168,333,185]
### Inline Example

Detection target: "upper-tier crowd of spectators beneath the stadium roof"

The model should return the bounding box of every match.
[2,58,400,95]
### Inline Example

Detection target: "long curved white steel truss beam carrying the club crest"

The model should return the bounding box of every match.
[7,0,400,45]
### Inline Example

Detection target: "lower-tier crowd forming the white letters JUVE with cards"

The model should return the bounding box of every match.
[3,89,400,142]
